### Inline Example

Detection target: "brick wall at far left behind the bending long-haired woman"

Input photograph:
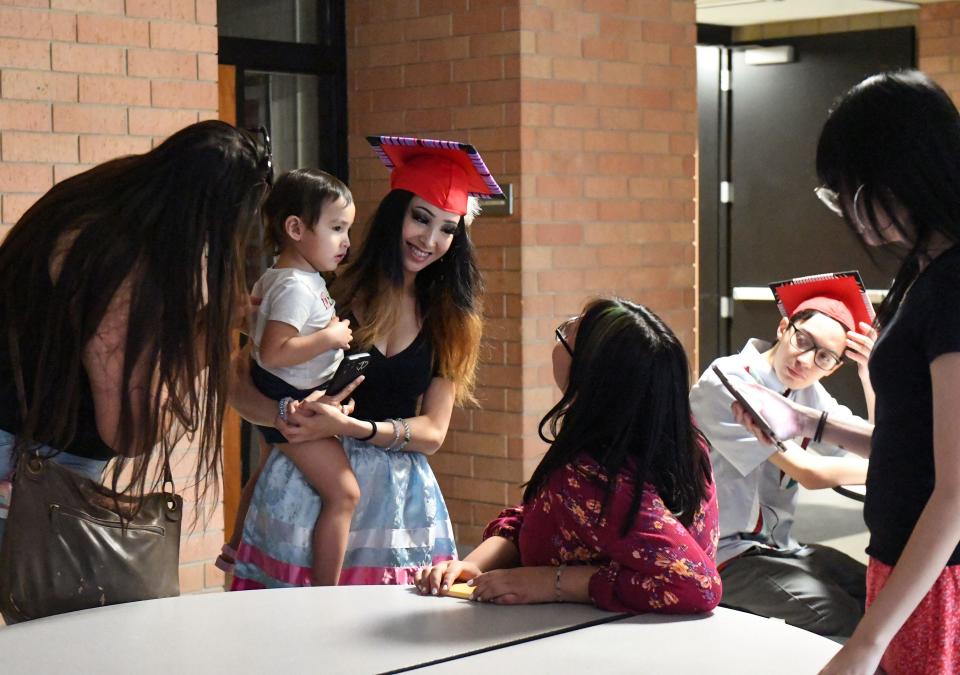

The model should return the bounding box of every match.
[0,0,223,593]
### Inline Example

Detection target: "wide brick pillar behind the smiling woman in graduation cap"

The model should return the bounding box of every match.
[347,0,696,545]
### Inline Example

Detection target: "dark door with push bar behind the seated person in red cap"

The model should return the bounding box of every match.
[697,28,915,415]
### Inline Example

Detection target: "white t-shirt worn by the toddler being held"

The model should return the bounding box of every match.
[250,267,343,389]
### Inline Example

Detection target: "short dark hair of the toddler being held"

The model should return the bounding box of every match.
[262,169,353,255]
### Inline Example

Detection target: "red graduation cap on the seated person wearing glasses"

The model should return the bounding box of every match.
[770,270,876,330]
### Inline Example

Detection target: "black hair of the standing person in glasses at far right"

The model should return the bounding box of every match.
[817,70,960,325]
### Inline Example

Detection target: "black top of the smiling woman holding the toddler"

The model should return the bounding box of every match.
[347,316,438,421]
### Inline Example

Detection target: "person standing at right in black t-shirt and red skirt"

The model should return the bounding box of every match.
[738,71,960,675]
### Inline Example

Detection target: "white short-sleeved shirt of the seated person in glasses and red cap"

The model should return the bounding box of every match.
[690,339,853,563]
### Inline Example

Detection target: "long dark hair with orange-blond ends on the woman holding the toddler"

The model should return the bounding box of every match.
[333,190,483,404]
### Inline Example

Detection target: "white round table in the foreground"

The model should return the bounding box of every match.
[0,586,839,675]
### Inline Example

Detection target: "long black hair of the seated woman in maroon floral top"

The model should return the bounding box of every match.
[523,298,711,535]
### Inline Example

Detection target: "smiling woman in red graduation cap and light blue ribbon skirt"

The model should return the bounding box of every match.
[233,137,500,590]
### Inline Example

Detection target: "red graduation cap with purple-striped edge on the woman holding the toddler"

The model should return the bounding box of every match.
[367,136,503,216]
